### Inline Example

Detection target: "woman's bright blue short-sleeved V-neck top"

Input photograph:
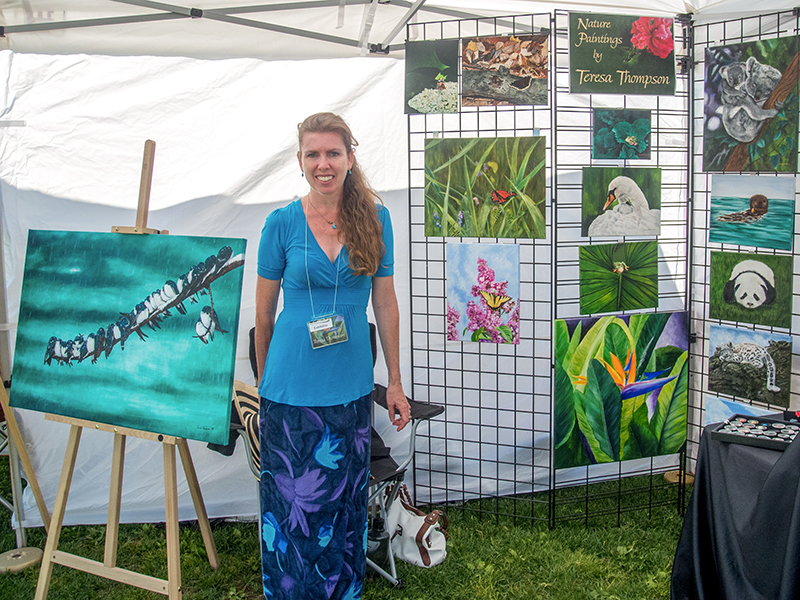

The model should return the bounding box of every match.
[258,200,394,406]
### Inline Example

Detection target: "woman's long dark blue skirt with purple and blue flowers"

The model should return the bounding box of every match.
[259,395,372,600]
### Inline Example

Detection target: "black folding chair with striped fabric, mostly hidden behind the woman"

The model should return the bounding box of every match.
[231,323,444,588]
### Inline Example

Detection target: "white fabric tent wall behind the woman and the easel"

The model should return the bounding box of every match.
[0,51,411,526]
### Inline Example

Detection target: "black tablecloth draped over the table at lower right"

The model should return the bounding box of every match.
[672,425,800,600]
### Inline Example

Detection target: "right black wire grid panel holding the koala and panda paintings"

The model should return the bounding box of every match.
[687,9,800,471]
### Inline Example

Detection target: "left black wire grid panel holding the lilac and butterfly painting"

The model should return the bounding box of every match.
[408,14,553,521]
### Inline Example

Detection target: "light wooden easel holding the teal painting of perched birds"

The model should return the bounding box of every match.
[35,140,219,600]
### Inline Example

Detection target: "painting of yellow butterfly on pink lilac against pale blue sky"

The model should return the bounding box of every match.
[446,243,519,344]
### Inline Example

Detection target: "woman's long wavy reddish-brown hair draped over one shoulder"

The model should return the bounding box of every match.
[297,113,386,275]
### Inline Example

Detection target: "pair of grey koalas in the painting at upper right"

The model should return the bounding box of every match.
[720,56,781,142]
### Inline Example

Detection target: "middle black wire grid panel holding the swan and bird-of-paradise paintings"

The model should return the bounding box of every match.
[553,11,691,522]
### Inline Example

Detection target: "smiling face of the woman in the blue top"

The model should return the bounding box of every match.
[297,132,353,196]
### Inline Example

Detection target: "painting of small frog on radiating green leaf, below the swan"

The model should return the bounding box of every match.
[578,241,658,315]
